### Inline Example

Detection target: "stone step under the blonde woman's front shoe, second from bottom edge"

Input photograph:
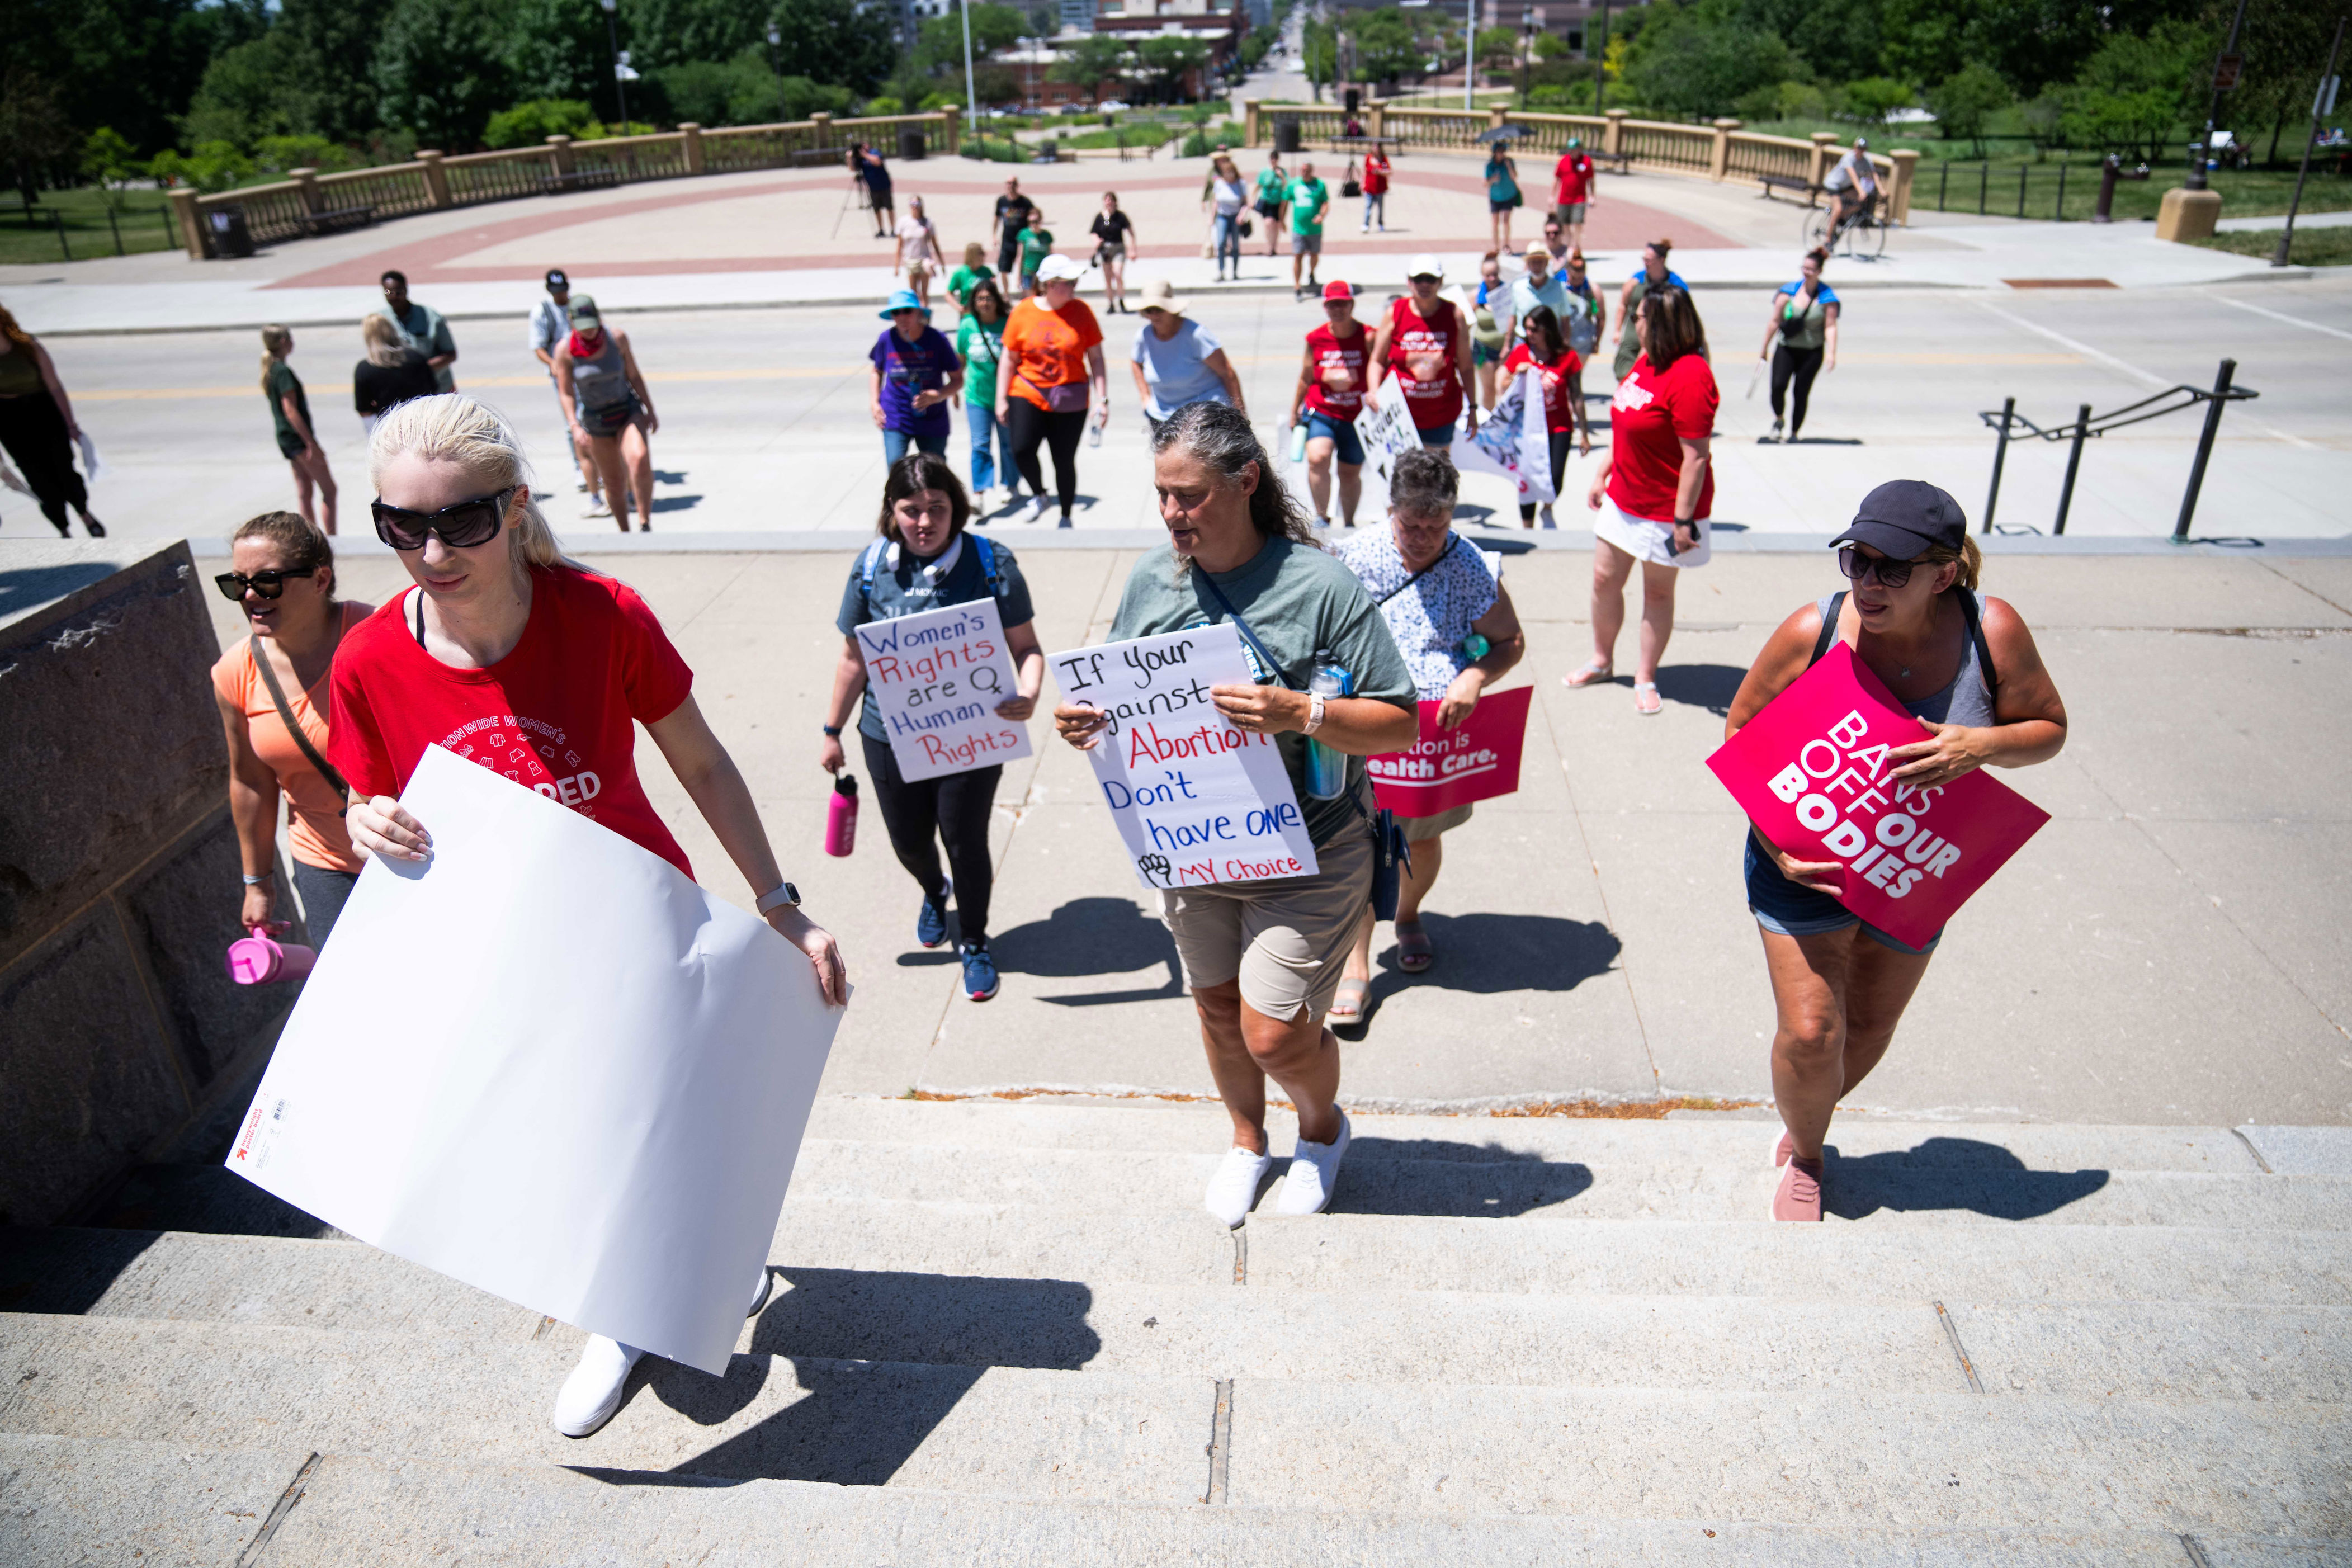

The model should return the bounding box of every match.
[0,1316,2352,1537]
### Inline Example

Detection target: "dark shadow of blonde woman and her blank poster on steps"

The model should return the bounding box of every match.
[630,1269,1103,1486]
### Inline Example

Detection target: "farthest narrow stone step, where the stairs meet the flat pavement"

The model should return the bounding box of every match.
[809,1095,2257,1175]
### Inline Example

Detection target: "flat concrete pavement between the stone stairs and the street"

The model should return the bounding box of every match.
[166,543,2352,1126]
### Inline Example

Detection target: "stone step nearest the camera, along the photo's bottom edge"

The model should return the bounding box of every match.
[13,1434,2296,1568]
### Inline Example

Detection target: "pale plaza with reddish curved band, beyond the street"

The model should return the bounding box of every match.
[0,153,2307,336]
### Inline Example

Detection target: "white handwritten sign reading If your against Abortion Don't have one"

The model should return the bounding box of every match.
[1047,625,1315,889]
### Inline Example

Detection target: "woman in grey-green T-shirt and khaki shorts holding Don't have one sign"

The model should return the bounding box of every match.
[1054,402,1420,1225]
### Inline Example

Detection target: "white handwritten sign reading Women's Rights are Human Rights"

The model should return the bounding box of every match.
[856,597,1030,783]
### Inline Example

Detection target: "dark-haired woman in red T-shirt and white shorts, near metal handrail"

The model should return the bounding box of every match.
[1560,285,1722,712]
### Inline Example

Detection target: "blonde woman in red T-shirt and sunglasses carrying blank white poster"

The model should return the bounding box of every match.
[327,393,849,1437]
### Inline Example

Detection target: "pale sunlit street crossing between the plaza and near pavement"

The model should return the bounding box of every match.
[23,277,2352,552]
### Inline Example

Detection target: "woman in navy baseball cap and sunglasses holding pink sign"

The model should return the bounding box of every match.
[1724,480,2067,1220]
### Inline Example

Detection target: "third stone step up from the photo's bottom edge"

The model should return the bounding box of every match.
[14,1232,2352,1404]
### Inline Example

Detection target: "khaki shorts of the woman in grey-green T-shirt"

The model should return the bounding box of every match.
[1160,823,1371,1020]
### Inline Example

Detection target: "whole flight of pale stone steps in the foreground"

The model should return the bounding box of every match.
[0,1098,2352,1568]
